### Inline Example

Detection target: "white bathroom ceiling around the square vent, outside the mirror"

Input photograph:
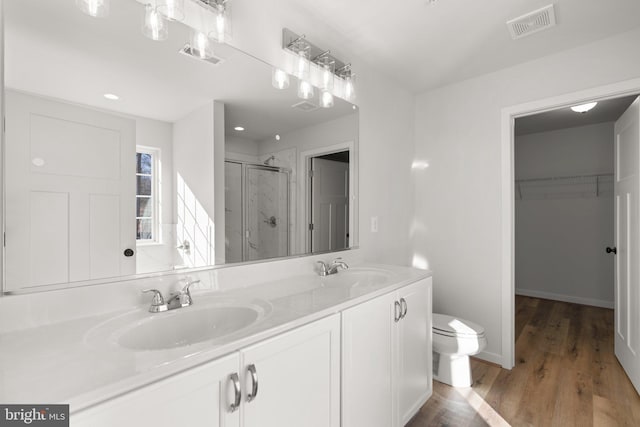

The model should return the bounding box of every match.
[289,0,640,92]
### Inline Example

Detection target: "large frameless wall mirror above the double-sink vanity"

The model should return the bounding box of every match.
[4,0,358,292]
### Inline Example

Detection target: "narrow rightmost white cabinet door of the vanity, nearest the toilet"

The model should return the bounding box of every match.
[395,278,433,426]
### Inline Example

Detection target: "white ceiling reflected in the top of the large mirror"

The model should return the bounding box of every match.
[4,0,354,141]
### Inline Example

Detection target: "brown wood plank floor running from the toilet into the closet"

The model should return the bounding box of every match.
[407,296,640,427]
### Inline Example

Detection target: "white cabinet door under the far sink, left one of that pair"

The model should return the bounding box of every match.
[342,292,396,427]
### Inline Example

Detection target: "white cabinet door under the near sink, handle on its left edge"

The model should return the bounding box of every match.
[240,314,340,427]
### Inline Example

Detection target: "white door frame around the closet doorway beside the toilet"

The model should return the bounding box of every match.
[500,79,640,369]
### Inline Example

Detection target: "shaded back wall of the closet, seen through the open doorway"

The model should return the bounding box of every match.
[514,123,614,307]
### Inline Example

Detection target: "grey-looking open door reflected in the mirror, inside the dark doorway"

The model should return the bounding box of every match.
[311,157,349,252]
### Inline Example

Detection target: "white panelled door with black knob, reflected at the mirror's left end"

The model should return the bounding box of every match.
[5,91,136,291]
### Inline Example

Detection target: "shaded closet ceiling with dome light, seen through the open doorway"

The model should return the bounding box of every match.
[515,95,638,135]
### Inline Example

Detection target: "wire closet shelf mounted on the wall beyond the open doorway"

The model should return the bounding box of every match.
[515,174,613,200]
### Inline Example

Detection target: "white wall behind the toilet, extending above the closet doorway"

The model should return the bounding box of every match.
[412,30,640,362]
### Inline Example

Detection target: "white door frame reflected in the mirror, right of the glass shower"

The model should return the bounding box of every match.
[296,141,357,253]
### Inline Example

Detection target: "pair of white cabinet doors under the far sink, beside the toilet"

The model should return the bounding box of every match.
[342,278,432,427]
